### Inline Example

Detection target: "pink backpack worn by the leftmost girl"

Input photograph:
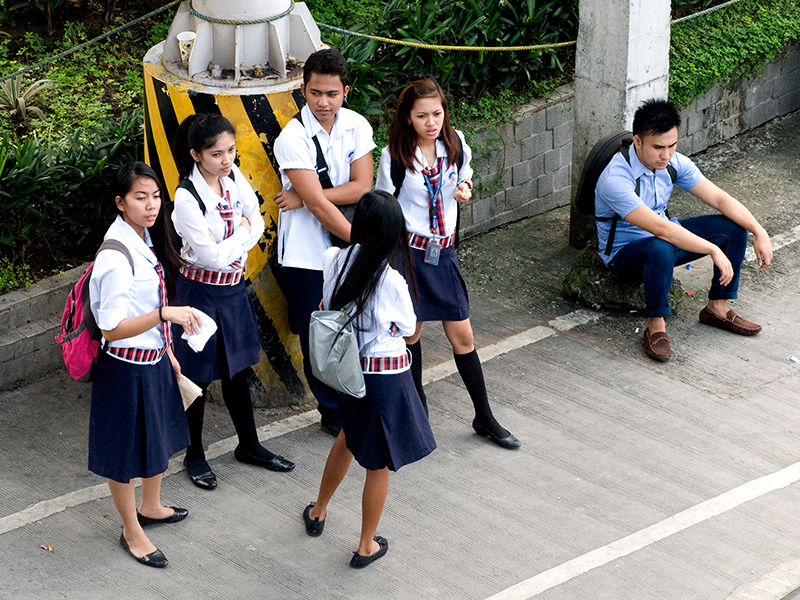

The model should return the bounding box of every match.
[56,240,134,383]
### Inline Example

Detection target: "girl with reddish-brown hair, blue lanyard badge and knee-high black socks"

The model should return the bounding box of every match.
[375,79,520,449]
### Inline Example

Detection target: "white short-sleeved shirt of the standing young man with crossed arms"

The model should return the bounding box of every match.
[274,106,375,271]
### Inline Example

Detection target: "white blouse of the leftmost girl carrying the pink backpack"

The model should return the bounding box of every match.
[89,215,164,356]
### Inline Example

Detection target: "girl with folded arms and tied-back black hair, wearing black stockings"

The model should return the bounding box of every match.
[172,115,294,490]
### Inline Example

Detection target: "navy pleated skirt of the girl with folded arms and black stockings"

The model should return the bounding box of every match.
[172,276,261,383]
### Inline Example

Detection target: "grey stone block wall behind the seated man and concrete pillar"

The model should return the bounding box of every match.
[461,45,800,238]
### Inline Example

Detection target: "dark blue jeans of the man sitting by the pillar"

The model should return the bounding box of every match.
[608,215,747,317]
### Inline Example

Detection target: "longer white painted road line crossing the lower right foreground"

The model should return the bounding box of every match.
[487,462,800,600]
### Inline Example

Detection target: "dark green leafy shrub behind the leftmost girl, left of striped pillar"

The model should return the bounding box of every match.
[0,110,144,263]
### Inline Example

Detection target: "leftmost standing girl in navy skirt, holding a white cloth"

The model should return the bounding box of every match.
[89,162,200,567]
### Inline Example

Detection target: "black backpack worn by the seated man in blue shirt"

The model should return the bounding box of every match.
[575,131,678,256]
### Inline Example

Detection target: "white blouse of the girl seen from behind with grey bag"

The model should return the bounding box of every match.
[322,244,417,373]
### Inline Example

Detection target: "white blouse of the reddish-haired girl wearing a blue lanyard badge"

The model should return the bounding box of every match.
[375,130,472,238]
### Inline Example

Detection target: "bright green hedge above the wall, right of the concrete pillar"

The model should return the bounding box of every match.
[669,0,800,107]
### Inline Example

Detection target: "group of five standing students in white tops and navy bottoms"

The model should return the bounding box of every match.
[89,49,520,568]
